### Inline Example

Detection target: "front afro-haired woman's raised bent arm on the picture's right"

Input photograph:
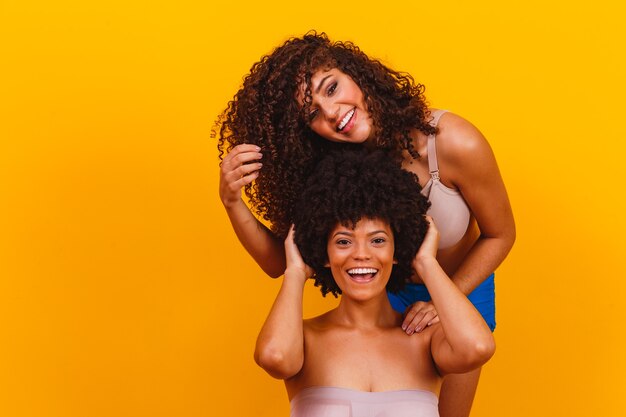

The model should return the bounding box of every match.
[413,218,495,375]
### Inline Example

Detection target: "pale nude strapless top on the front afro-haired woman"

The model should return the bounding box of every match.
[290,387,439,417]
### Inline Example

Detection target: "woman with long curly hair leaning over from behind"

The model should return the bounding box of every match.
[215,33,515,417]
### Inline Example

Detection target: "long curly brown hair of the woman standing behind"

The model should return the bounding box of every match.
[212,32,436,238]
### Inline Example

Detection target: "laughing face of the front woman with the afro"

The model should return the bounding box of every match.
[327,218,395,300]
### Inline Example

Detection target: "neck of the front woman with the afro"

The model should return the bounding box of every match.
[335,292,402,329]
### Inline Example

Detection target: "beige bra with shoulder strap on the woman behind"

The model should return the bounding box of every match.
[422,110,470,249]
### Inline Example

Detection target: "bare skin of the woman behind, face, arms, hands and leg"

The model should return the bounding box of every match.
[220,64,515,417]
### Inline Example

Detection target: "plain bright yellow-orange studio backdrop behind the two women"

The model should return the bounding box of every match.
[0,0,626,417]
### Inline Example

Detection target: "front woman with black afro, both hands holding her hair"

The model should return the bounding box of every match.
[255,150,495,417]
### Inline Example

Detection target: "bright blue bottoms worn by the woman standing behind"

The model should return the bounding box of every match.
[387,274,496,332]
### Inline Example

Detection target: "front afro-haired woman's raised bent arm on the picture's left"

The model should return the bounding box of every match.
[254,228,307,379]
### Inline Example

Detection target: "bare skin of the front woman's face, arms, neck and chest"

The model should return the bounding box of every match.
[255,218,495,399]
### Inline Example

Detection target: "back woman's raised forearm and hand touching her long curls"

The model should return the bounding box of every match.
[220,144,285,278]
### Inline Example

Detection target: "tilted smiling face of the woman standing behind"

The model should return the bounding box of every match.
[300,68,373,143]
